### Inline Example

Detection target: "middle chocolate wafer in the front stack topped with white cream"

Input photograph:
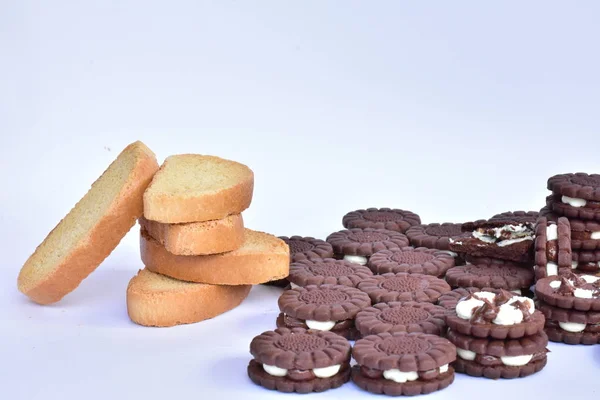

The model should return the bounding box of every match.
[446,330,548,358]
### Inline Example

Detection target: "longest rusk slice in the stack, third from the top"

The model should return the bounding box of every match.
[140,229,290,285]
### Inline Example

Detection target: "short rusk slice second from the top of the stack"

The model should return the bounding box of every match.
[140,214,244,256]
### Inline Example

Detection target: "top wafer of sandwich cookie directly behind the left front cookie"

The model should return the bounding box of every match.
[278,285,371,322]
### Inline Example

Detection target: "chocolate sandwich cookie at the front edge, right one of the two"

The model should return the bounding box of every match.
[352,332,456,396]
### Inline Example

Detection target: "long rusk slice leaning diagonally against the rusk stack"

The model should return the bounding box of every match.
[18,142,158,304]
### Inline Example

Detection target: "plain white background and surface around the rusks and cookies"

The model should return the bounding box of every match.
[0,1,600,400]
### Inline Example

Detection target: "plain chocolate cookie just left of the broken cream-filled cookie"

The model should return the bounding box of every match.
[406,222,471,250]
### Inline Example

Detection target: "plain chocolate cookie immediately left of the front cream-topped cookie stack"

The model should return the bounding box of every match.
[355,301,446,337]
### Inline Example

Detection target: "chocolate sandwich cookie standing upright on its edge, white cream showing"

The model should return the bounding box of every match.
[534,217,573,279]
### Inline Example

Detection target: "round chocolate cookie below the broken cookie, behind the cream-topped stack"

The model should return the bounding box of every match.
[446,258,534,291]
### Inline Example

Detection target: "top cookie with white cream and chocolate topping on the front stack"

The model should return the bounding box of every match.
[446,290,545,340]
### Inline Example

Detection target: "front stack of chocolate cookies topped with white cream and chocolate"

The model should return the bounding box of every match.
[440,288,548,379]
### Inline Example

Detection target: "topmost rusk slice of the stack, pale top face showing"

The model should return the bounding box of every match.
[144,154,254,224]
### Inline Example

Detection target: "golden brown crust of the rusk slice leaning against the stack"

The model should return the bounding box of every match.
[18,142,158,304]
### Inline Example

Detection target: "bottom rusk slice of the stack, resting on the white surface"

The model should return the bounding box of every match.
[127,269,252,326]
